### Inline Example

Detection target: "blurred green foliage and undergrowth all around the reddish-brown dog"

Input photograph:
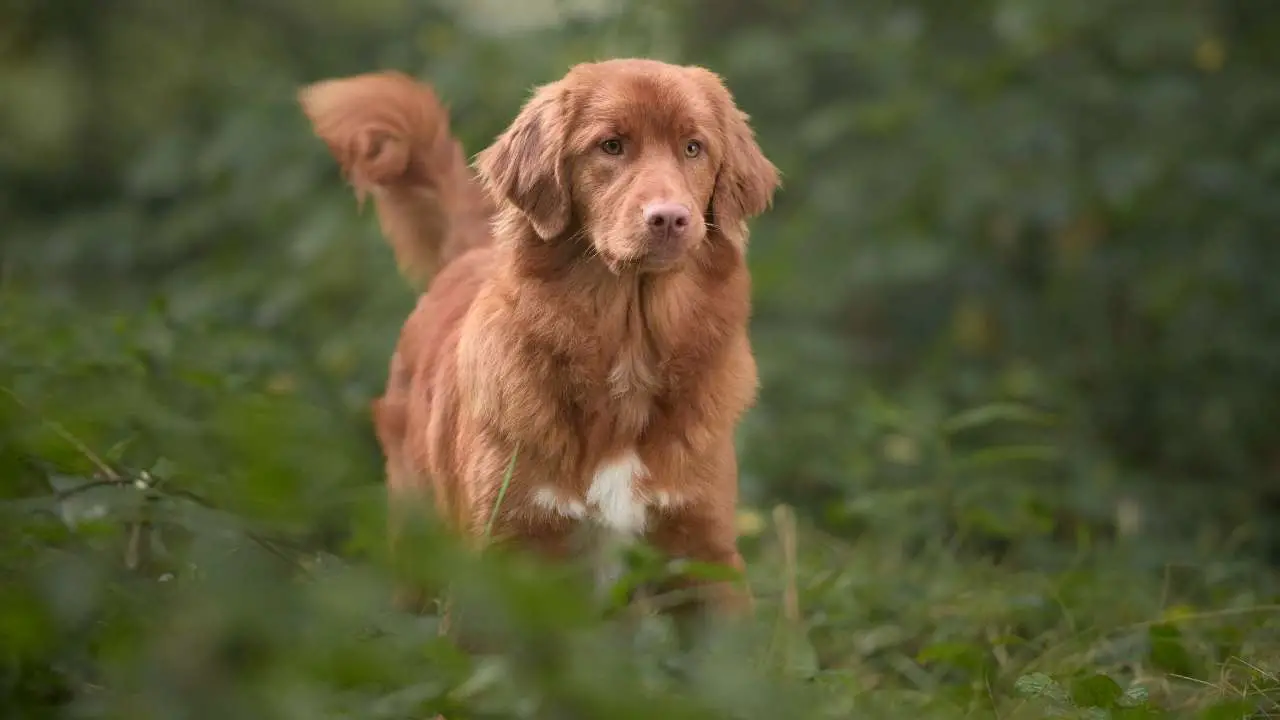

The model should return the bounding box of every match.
[0,0,1280,719]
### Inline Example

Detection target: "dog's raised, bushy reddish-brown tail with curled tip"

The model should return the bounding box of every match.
[298,72,493,287]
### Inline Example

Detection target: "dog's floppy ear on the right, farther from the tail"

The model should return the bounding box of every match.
[694,68,781,229]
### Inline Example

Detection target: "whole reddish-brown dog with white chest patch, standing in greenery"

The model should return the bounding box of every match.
[301,59,778,627]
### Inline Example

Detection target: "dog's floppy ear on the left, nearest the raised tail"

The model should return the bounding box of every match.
[476,83,570,240]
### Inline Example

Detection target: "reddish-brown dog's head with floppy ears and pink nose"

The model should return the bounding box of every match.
[477,59,778,272]
